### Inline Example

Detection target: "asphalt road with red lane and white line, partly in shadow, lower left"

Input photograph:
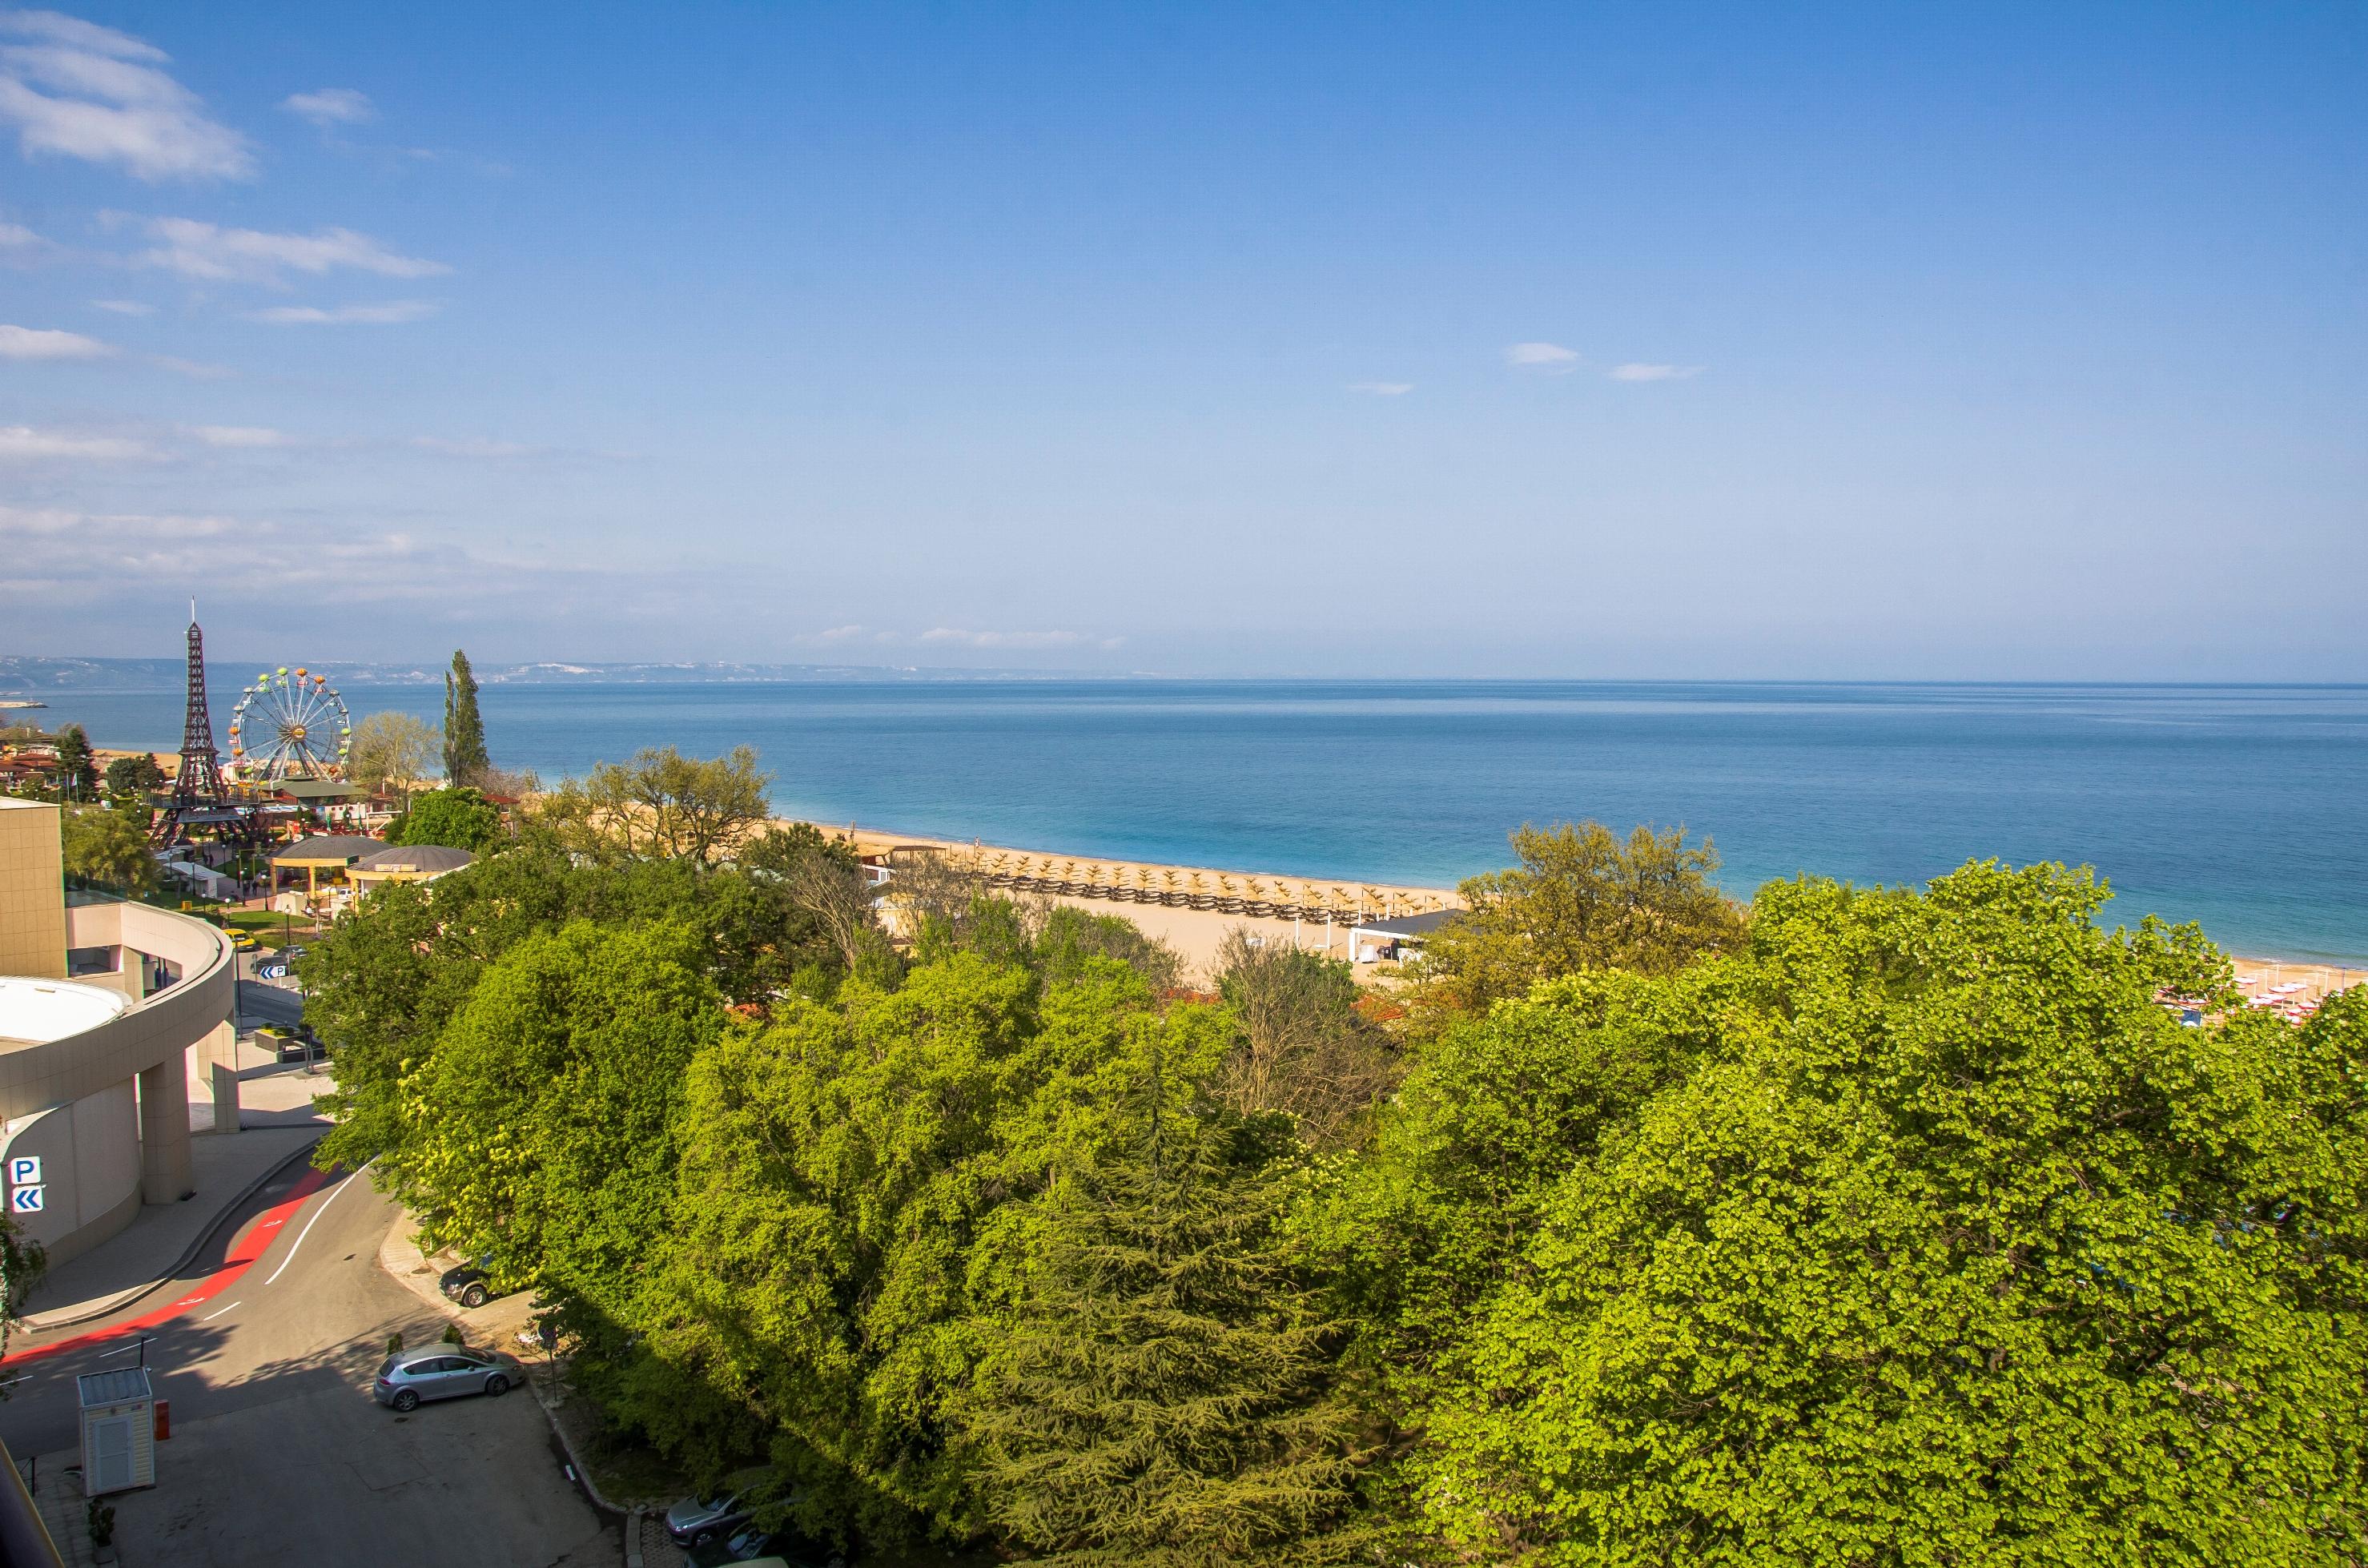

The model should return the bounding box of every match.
[0,1156,623,1568]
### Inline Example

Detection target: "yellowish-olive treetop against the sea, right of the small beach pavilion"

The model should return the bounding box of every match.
[1418,822,1745,1009]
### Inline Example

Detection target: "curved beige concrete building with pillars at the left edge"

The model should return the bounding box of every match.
[0,798,237,1264]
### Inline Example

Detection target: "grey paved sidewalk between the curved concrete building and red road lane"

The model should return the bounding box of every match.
[24,1120,329,1331]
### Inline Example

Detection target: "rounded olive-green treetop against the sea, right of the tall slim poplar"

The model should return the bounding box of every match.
[537,746,772,860]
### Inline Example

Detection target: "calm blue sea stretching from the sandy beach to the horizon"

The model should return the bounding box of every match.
[33,680,2368,964]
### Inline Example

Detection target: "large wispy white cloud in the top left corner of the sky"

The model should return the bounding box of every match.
[0,12,255,180]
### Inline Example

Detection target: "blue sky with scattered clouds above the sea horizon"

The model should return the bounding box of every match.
[0,5,2368,680]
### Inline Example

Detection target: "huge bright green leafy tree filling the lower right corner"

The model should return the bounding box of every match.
[1369,865,2368,1563]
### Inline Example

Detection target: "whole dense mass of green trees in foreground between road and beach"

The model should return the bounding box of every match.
[303,819,2368,1566]
